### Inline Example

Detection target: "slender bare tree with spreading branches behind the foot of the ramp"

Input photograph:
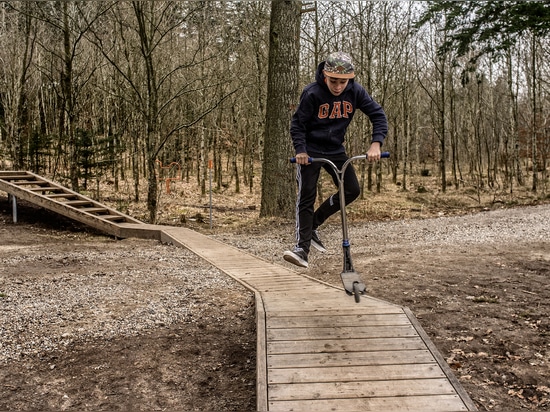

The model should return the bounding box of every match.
[88,1,236,222]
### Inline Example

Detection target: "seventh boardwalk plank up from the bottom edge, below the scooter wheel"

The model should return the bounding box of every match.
[268,312,410,329]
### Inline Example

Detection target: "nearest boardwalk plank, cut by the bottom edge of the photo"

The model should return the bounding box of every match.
[269,395,467,412]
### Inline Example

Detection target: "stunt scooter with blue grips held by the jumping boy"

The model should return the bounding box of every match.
[290,152,390,303]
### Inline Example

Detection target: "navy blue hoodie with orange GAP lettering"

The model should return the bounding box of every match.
[290,62,388,155]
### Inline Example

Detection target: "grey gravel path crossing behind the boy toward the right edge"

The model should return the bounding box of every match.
[215,204,550,268]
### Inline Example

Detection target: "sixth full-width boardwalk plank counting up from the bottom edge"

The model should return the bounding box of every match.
[267,324,418,342]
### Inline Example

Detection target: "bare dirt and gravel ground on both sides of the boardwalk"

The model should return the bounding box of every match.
[0,197,550,411]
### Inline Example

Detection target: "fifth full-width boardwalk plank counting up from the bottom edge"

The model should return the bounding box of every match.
[267,337,426,355]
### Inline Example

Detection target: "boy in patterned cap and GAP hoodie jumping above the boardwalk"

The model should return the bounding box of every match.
[283,52,388,268]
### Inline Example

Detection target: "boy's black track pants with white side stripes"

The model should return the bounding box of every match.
[296,154,361,253]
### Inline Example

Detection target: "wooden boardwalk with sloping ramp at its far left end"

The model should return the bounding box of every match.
[0,172,476,412]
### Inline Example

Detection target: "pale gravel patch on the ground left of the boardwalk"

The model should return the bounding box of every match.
[0,235,246,364]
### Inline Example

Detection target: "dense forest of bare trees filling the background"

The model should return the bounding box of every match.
[0,1,550,222]
